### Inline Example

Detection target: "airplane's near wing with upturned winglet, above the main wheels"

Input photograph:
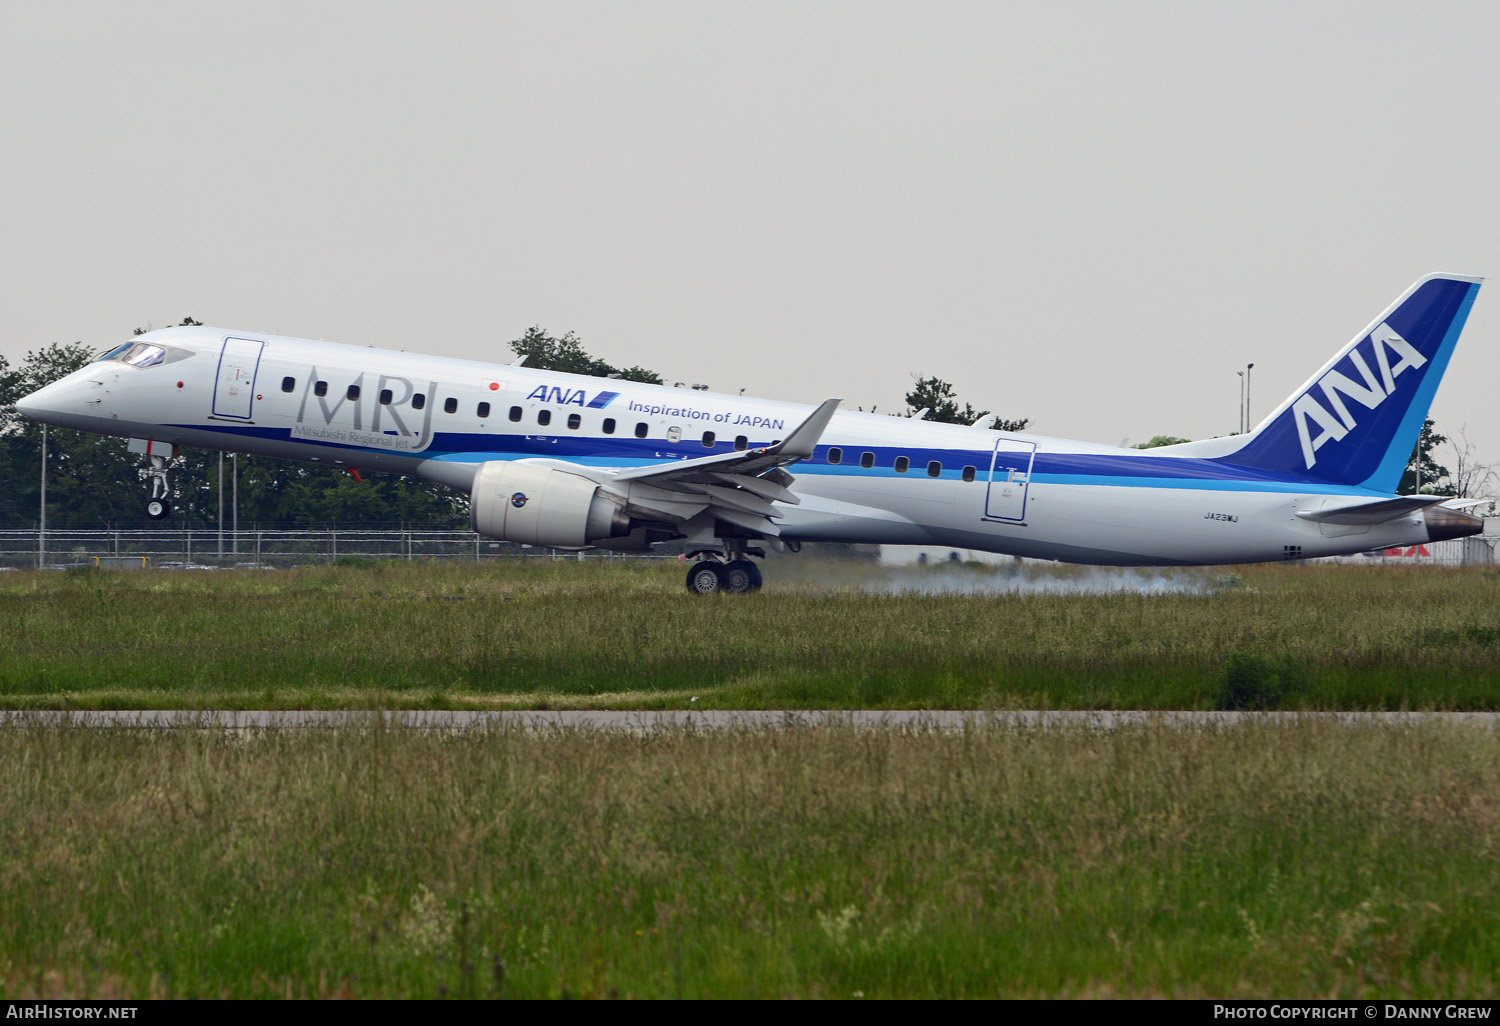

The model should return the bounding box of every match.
[603,399,840,537]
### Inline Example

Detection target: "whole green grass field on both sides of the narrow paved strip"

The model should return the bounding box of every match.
[0,560,1500,998]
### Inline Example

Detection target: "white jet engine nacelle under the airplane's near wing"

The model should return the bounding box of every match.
[470,461,630,549]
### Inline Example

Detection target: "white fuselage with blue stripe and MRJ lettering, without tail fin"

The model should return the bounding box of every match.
[20,327,1452,566]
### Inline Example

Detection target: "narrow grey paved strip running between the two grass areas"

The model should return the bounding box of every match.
[0,710,1500,734]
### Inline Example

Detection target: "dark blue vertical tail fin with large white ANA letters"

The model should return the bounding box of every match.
[1221,275,1482,492]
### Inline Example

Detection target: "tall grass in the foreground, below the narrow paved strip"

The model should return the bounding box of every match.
[0,725,1500,998]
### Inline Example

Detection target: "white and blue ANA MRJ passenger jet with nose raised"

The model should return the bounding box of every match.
[17,275,1482,594]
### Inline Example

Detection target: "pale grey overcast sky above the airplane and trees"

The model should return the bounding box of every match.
[0,0,1500,461]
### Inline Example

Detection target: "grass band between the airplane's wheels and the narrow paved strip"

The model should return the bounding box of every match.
[0,560,1500,710]
